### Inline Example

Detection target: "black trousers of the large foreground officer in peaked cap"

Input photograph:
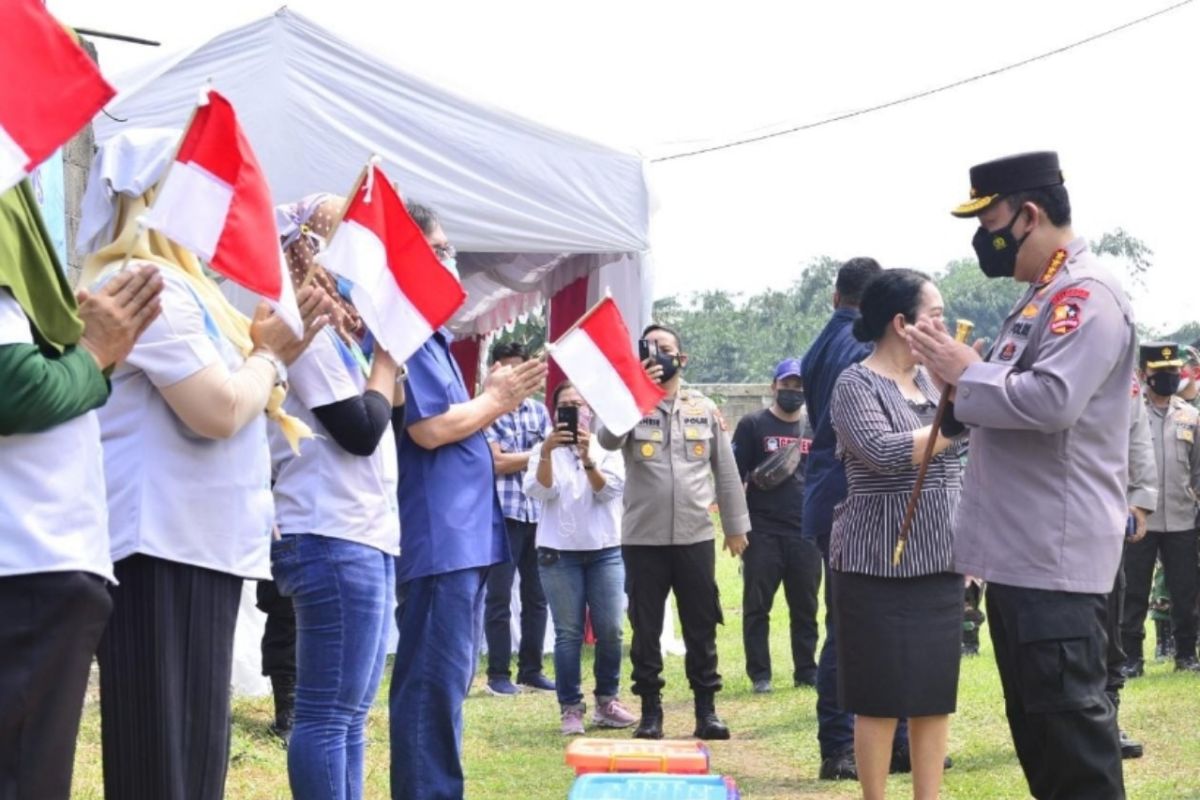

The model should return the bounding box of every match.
[988,583,1126,800]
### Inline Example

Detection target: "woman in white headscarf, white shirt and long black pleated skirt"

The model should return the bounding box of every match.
[80,131,326,800]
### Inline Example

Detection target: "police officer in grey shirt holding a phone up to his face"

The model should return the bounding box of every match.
[596,325,750,739]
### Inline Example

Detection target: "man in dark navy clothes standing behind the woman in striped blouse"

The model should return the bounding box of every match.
[800,258,882,780]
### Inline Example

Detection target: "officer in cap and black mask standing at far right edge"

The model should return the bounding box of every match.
[1121,342,1200,678]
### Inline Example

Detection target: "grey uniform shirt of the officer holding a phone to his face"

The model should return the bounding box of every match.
[596,389,750,545]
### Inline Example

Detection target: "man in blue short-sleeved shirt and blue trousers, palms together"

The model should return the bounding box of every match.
[389,204,546,800]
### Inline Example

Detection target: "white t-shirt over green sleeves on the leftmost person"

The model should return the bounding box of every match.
[0,289,113,581]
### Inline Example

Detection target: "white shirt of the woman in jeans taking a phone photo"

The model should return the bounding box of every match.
[524,439,625,551]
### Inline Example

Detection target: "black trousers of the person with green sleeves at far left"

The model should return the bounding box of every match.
[0,572,113,800]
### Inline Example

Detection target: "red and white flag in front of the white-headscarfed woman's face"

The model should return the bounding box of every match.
[145,90,284,305]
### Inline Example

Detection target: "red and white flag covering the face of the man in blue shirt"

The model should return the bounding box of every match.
[317,160,467,362]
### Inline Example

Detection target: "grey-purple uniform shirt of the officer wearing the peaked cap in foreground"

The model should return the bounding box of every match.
[955,239,1136,594]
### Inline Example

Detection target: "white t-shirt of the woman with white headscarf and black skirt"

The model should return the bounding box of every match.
[100,269,275,579]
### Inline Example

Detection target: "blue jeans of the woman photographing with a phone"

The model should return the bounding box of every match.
[538,546,625,705]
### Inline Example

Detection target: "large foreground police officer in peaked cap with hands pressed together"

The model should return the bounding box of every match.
[910,152,1136,800]
